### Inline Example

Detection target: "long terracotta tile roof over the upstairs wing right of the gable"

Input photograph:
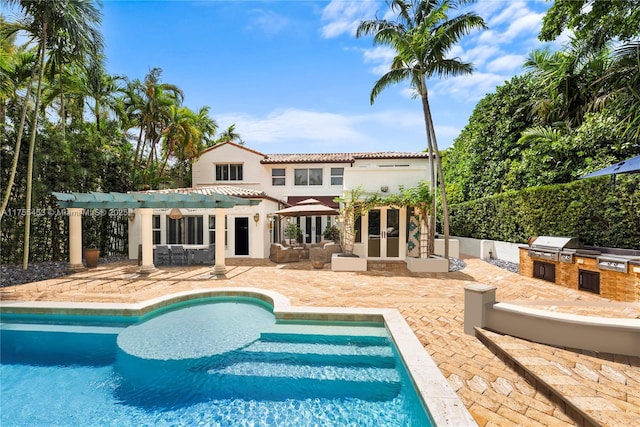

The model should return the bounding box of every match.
[260,151,429,164]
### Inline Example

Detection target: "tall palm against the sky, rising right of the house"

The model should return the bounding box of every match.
[356,0,486,258]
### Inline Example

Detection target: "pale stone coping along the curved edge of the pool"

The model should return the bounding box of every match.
[0,287,477,426]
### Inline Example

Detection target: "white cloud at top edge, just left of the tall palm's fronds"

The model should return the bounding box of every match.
[322,0,379,38]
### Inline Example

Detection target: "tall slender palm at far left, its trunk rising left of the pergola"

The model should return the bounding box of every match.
[8,0,103,270]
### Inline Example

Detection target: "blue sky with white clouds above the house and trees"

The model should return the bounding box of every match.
[50,0,568,153]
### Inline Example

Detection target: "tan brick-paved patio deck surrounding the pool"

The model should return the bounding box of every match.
[0,258,640,426]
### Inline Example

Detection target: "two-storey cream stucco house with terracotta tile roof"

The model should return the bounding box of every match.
[129,142,438,266]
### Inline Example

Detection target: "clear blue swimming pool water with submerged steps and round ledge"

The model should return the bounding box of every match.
[0,300,431,427]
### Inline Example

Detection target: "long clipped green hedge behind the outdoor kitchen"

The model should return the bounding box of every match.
[449,174,640,249]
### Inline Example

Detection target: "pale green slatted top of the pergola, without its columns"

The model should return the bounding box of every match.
[52,192,260,209]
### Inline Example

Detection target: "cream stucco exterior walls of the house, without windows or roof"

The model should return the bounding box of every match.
[129,143,430,259]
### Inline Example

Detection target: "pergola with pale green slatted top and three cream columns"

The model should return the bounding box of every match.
[52,192,260,276]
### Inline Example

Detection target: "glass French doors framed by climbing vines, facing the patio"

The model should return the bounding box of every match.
[367,208,406,258]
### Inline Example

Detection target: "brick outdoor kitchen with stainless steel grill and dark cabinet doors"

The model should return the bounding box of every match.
[519,236,640,302]
